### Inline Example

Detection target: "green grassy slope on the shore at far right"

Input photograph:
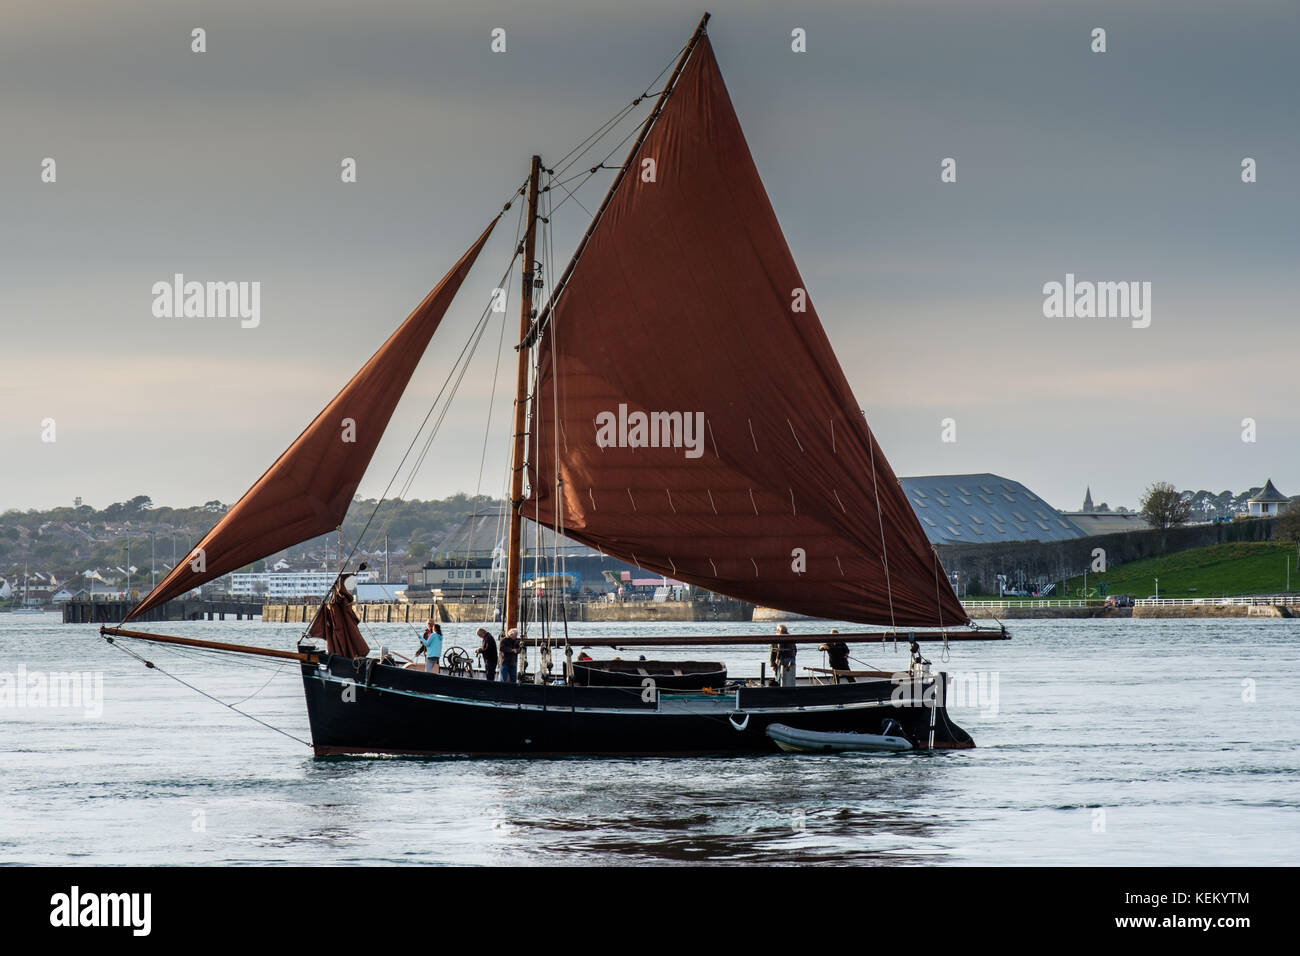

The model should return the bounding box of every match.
[1053,541,1300,597]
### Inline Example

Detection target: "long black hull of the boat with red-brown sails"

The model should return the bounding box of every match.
[302,656,975,756]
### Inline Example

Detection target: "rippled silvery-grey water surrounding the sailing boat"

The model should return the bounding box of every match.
[0,615,1300,865]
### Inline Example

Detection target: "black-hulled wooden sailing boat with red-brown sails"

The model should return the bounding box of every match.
[101,14,1006,754]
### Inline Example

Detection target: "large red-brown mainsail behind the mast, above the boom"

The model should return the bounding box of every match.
[523,36,967,626]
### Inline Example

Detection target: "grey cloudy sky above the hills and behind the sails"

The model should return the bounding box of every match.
[0,0,1300,509]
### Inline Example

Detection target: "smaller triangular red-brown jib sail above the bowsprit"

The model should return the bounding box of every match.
[126,220,497,620]
